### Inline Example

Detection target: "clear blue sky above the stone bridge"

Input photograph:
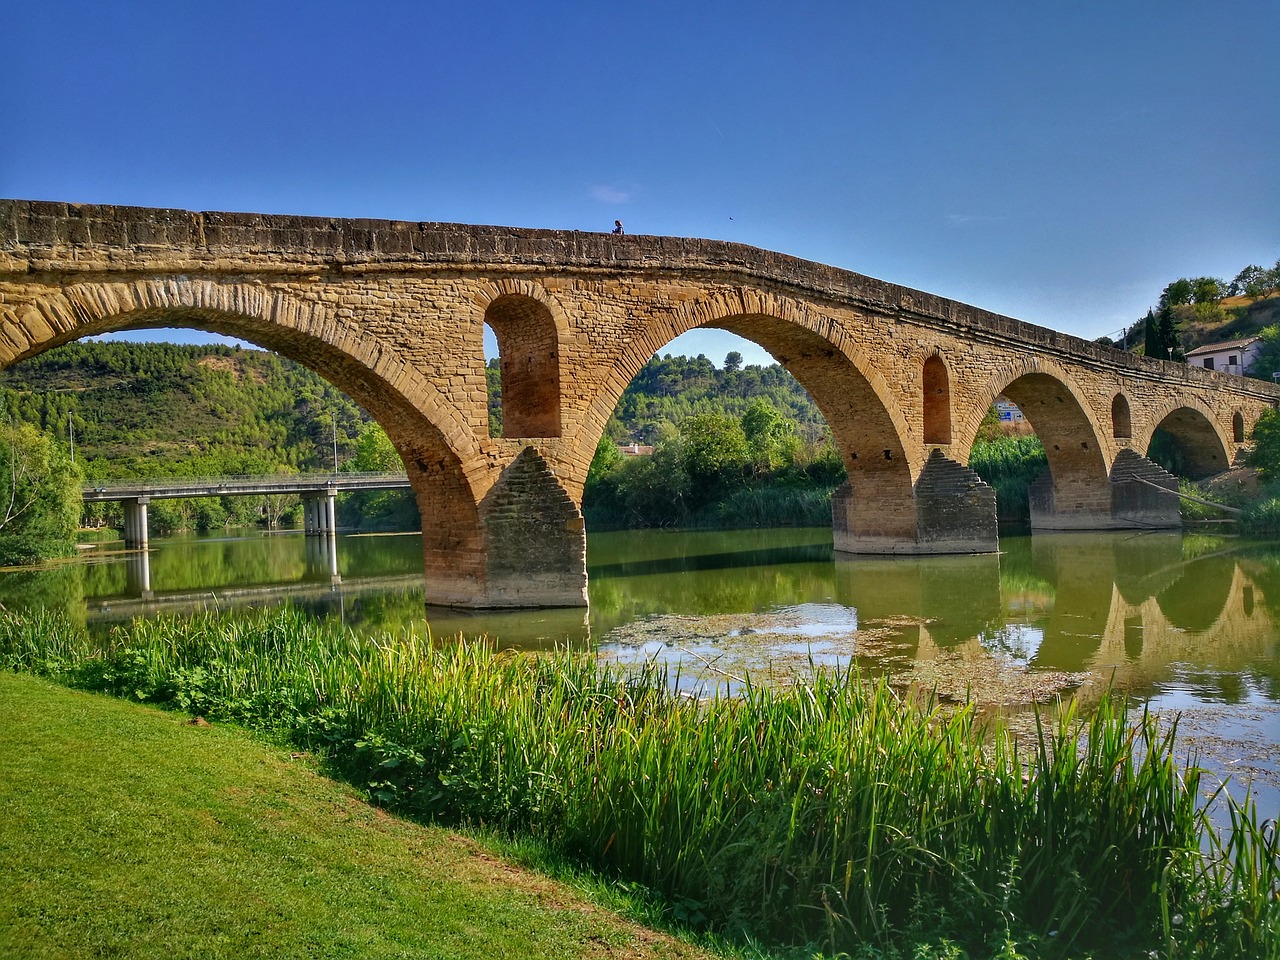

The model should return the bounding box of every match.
[0,0,1280,362]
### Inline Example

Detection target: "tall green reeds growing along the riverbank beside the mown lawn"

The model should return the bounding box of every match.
[0,611,1280,956]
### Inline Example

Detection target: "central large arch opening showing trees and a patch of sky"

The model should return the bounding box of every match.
[582,333,845,531]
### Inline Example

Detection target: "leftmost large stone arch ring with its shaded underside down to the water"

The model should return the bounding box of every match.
[0,278,517,603]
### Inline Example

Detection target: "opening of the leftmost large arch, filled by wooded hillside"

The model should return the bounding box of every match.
[0,335,430,535]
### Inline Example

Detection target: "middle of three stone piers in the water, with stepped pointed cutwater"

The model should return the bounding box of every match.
[831,449,1000,554]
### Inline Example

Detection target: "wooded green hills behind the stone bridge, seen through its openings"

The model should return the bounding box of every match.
[0,340,826,480]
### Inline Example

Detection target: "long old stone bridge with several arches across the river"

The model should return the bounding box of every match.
[0,201,1280,607]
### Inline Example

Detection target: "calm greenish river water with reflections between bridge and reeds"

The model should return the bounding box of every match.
[10,530,1280,815]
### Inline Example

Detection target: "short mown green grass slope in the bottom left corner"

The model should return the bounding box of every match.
[0,673,699,960]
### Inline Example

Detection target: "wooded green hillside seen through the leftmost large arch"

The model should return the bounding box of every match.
[0,340,369,480]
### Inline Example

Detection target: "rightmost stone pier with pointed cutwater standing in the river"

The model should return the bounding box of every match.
[1030,449,1183,531]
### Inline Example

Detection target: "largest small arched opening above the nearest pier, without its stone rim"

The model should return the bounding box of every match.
[484,293,561,439]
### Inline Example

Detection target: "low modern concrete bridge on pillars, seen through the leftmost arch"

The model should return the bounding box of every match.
[84,474,411,548]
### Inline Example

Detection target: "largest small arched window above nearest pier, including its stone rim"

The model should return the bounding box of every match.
[480,280,568,439]
